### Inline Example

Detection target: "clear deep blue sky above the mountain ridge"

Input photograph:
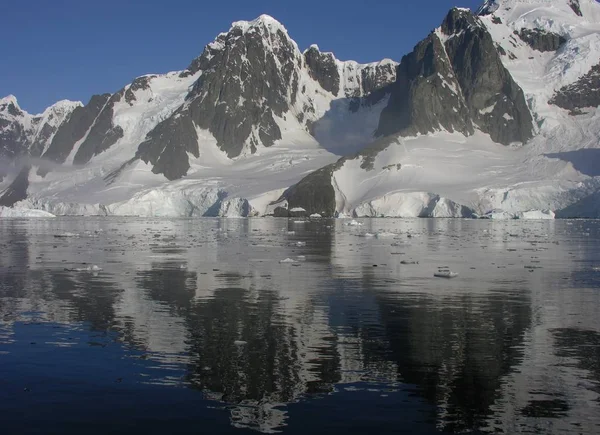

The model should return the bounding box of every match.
[0,0,483,113]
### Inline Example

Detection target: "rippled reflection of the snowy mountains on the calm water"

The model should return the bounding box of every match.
[0,220,600,432]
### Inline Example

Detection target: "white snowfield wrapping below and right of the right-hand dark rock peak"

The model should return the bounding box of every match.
[284,0,600,218]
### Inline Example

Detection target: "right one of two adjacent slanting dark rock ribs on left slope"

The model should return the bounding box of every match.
[73,91,125,165]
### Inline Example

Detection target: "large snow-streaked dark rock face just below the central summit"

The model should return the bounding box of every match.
[188,22,299,158]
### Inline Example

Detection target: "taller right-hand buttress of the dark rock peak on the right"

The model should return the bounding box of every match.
[442,8,533,145]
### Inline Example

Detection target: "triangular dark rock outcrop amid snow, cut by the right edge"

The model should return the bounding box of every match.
[549,64,600,114]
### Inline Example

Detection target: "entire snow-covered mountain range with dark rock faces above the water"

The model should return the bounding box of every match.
[0,0,600,217]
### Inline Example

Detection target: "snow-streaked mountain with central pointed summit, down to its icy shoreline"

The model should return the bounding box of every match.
[5,15,396,216]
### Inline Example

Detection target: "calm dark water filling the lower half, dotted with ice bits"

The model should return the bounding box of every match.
[0,218,600,434]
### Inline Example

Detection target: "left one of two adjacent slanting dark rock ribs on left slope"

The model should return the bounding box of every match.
[40,94,111,167]
